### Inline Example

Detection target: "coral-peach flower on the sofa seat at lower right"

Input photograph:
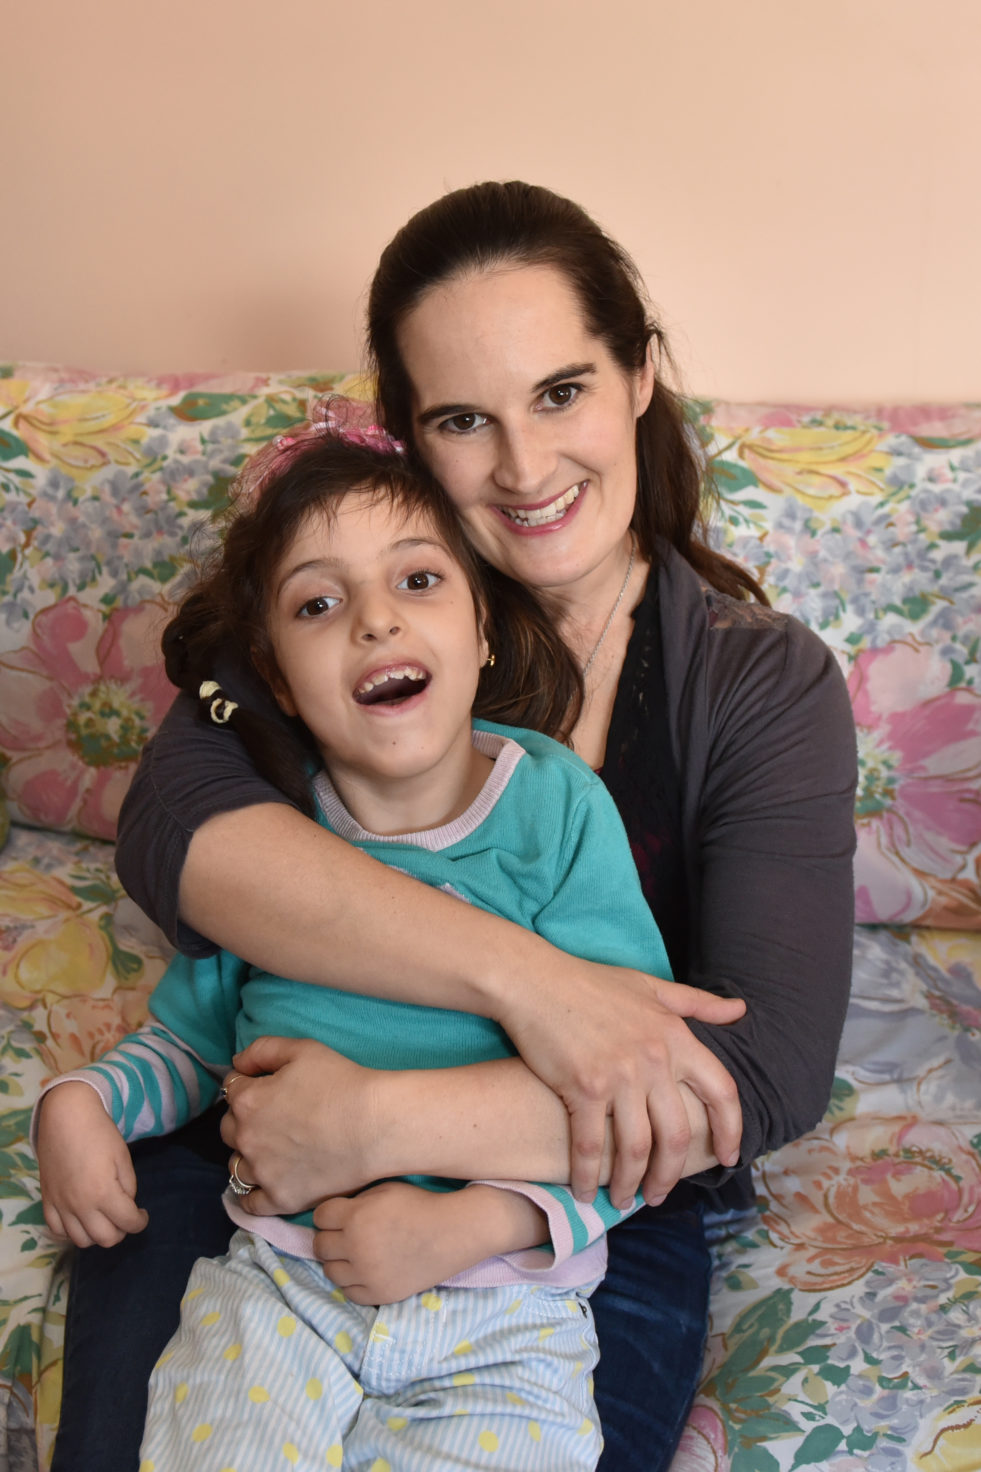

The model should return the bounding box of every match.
[760,1114,981,1292]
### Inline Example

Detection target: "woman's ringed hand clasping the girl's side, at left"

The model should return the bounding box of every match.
[221,1038,384,1216]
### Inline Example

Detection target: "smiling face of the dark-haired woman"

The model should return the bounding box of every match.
[398,265,654,598]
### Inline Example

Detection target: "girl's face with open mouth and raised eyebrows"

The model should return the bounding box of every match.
[268,492,488,826]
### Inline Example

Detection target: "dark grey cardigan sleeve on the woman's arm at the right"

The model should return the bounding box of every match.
[671,599,857,1185]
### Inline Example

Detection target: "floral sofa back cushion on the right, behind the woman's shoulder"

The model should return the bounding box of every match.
[695,403,981,929]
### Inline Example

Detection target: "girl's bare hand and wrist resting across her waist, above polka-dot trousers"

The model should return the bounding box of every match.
[314,1181,548,1304]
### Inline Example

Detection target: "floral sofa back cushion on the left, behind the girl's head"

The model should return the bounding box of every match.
[0,364,366,838]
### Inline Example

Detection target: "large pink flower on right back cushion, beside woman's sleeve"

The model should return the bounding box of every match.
[848,640,981,927]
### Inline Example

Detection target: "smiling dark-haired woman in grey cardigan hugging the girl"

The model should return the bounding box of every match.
[49,184,854,1472]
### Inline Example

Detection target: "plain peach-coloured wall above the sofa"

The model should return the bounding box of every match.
[0,0,981,399]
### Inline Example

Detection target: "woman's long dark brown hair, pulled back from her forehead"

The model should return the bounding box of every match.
[368,183,766,602]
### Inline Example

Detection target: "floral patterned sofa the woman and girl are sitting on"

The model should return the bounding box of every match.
[0,364,981,1472]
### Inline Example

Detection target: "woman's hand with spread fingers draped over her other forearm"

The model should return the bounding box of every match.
[498,957,745,1206]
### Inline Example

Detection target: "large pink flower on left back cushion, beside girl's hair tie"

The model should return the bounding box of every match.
[0,598,174,838]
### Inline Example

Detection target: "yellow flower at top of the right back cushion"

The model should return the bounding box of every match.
[739,425,890,509]
